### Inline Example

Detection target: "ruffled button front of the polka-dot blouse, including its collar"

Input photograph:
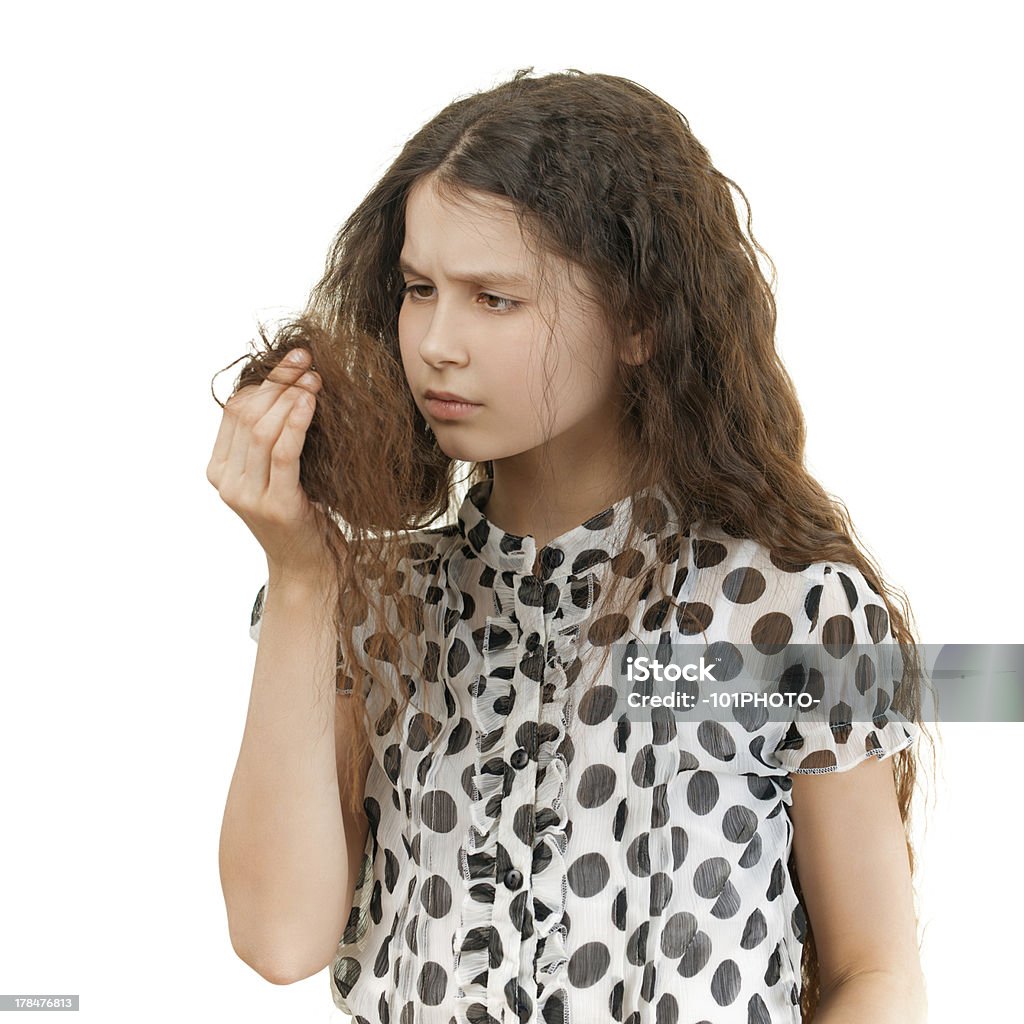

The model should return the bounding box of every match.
[457,480,679,1024]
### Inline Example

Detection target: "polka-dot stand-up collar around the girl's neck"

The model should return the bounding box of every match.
[459,477,675,580]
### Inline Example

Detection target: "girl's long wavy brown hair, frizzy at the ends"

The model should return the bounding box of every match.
[214,68,935,1021]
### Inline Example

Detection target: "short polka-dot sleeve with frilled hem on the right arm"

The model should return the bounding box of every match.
[771,562,921,774]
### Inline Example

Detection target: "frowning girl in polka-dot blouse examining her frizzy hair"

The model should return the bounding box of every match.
[208,69,925,1024]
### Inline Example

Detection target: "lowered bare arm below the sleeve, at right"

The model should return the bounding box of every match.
[791,757,927,1024]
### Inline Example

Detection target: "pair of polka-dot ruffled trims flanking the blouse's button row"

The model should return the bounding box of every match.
[453,571,595,1021]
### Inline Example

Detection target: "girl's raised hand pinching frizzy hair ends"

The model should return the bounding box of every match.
[206,348,329,582]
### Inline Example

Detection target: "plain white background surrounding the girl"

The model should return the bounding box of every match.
[0,0,1022,1024]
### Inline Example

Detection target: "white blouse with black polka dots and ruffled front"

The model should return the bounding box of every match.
[251,480,918,1024]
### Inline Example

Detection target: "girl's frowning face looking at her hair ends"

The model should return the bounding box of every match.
[398,178,618,469]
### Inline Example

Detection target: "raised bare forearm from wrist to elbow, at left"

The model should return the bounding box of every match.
[220,575,348,983]
